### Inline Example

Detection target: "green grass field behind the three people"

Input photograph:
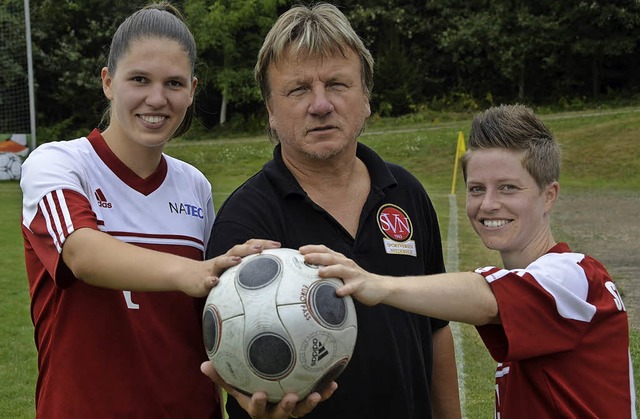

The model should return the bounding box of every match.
[0,108,640,418]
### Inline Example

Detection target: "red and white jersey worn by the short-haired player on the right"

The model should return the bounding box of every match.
[476,243,636,419]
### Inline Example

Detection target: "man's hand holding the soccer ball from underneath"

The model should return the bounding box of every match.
[200,361,338,419]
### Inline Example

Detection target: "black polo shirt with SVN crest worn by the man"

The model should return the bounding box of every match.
[207,143,446,419]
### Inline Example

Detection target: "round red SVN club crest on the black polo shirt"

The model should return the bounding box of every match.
[377,204,418,256]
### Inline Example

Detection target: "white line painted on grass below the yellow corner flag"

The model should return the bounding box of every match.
[445,195,467,418]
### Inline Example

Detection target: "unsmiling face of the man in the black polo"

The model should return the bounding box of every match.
[267,49,371,162]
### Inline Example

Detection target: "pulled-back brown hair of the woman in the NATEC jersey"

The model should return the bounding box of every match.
[101,1,197,138]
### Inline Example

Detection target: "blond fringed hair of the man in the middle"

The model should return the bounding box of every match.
[255,3,373,102]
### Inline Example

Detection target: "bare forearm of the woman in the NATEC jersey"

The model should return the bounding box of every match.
[62,228,195,291]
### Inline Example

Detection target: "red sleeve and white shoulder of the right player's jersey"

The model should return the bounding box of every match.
[476,246,621,361]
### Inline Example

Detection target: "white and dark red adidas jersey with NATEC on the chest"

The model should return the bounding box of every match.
[21,130,221,419]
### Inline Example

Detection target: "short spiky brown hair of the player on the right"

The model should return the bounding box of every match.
[462,104,561,190]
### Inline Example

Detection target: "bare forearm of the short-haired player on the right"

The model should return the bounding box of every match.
[381,272,499,325]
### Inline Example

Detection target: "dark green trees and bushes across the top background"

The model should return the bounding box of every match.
[7,0,640,138]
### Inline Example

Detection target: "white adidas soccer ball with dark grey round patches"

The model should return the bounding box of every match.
[202,248,357,402]
